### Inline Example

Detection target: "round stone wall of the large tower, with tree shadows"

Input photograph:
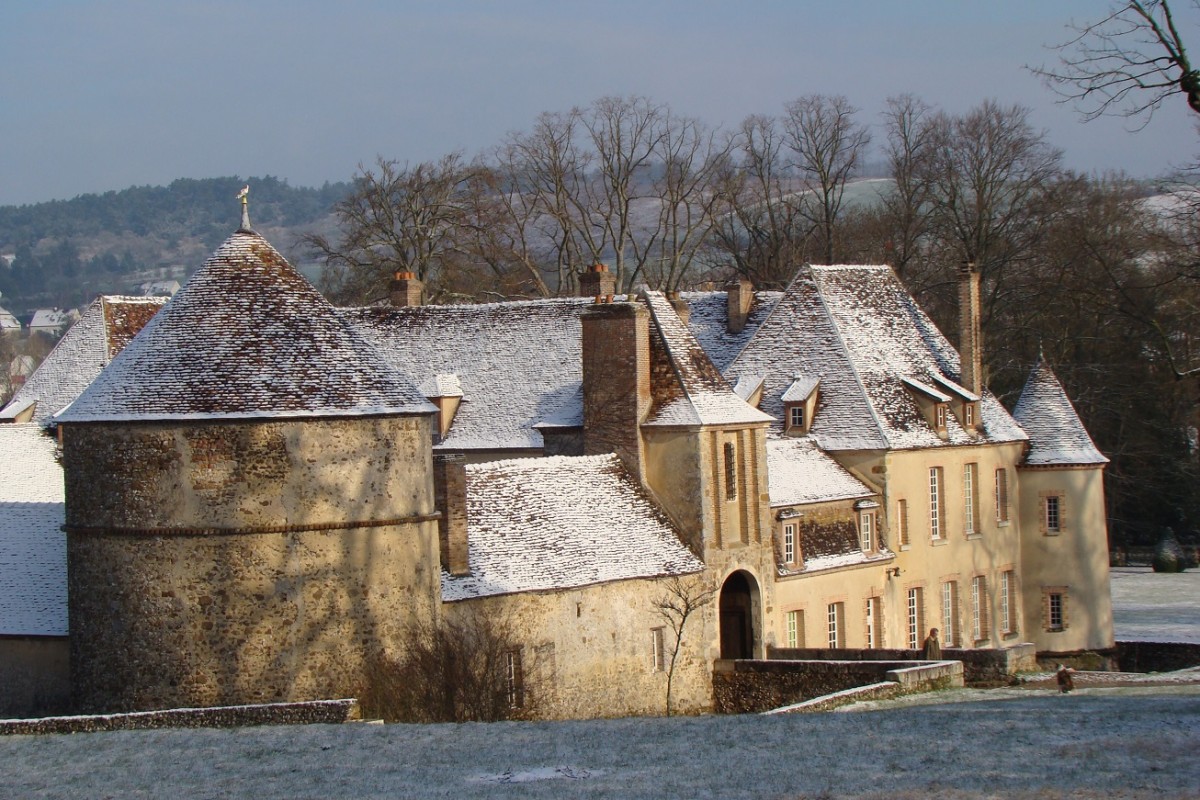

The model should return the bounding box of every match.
[64,417,440,712]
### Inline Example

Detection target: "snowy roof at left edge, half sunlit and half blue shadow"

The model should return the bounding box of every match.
[0,423,67,636]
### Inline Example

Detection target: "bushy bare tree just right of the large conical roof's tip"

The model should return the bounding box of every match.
[304,152,472,302]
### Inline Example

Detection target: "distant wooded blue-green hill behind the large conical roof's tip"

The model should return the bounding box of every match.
[0,176,350,324]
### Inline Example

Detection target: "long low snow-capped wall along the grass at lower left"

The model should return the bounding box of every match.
[0,699,360,735]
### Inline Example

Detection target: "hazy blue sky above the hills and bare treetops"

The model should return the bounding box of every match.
[0,0,1200,204]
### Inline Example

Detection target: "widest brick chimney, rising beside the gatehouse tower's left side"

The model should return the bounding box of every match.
[580,302,650,480]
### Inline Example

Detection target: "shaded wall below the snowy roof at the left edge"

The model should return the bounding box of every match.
[0,636,71,717]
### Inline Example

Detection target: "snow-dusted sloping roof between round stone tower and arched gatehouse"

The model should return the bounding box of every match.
[442,455,704,601]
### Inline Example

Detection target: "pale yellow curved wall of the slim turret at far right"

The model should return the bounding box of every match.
[1020,468,1114,652]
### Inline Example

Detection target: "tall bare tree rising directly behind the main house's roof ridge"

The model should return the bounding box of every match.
[784,95,871,264]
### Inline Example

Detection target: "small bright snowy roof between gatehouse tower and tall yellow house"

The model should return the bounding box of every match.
[767,438,875,507]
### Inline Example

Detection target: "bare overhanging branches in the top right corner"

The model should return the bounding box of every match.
[1033,0,1200,126]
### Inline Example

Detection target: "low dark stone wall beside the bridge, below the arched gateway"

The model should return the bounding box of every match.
[713,658,962,714]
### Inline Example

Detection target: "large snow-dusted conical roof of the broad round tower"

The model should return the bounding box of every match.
[56,228,436,422]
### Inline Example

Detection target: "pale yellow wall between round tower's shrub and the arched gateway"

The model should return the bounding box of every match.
[443,576,715,718]
